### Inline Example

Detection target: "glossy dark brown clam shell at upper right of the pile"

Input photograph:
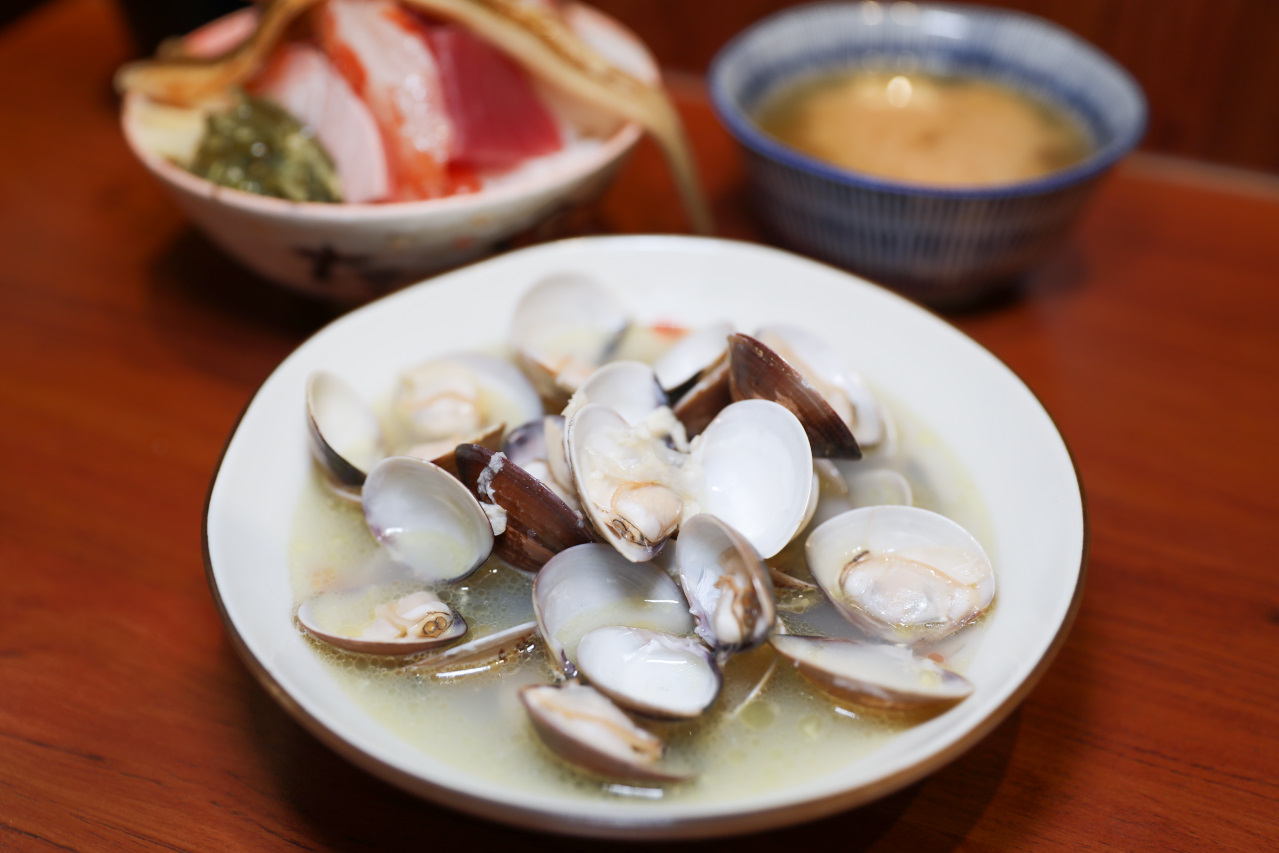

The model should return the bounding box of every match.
[729,334,862,459]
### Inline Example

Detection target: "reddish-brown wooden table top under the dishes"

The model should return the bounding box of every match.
[0,0,1279,850]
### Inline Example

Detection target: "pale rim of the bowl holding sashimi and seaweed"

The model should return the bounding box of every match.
[120,3,649,223]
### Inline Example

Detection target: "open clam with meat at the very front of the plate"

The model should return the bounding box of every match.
[519,682,688,781]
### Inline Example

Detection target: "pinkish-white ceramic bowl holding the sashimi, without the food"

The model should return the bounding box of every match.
[122,4,657,304]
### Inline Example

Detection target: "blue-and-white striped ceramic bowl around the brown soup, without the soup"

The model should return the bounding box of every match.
[710,3,1146,307]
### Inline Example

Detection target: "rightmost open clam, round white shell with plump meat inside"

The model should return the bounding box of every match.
[804,506,995,643]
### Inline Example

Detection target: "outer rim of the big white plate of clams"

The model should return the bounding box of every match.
[201,235,1091,840]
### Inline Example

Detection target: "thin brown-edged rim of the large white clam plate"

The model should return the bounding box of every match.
[201,235,1091,840]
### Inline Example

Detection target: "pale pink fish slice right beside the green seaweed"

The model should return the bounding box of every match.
[251,43,390,203]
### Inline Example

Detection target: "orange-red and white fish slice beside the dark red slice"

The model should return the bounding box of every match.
[318,0,454,201]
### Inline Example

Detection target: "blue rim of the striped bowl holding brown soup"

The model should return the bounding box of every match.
[706,0,1150,201]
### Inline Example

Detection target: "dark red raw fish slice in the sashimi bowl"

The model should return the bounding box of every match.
[428,26,561,171]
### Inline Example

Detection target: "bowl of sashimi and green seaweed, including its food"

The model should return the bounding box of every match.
[116,0,680,303]
